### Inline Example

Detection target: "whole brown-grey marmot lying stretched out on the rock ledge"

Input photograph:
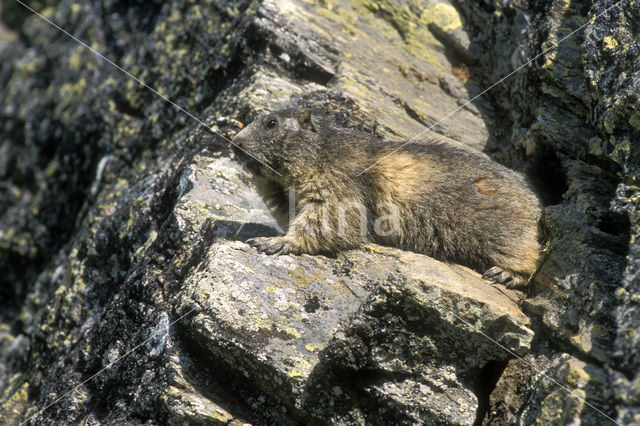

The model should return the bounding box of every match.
[233,109,540,287]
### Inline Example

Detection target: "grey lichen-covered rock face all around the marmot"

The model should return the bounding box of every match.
[0,0,640,425]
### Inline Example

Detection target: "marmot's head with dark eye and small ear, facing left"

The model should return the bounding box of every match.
[233,108,319,176]
